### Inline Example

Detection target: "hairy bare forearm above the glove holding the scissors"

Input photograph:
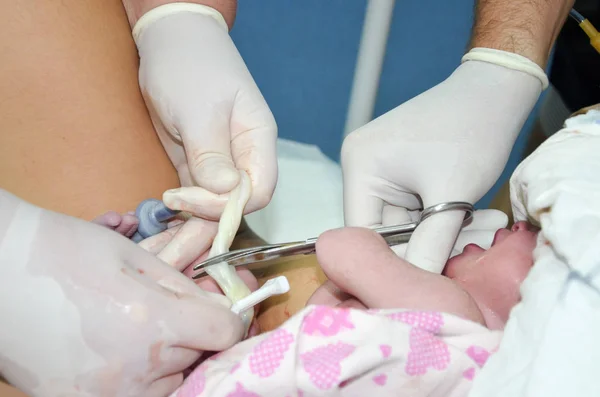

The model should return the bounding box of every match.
[470,0,575,68]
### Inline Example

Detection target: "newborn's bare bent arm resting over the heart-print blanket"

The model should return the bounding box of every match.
[309,228,484,324]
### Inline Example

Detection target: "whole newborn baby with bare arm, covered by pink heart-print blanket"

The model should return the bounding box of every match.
[173,222,537,397]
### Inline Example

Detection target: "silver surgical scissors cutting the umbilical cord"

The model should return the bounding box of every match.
[192,201,474,279]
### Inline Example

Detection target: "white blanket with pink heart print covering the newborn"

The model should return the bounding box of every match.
[173,306,502,397]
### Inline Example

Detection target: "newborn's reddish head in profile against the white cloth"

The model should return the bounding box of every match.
[444,222,537,329]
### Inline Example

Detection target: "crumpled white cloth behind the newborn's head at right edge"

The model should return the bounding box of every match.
[470,110,600,397]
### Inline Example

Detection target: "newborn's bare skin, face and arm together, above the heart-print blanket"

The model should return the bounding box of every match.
[308,222,537,330]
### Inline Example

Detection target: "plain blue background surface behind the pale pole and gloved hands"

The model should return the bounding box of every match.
[231,0,537,208]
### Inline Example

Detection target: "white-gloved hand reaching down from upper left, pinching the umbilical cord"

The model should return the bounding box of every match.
[133,3,277,260]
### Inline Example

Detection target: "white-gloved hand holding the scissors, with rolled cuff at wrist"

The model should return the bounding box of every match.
[342,49,547,273]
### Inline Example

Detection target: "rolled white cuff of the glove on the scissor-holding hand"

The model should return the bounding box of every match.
[461,47,549,90]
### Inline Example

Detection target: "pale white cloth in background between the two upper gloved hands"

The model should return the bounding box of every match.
[246,139,344,243]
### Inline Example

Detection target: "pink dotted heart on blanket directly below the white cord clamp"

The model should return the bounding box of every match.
[248,329,294,378]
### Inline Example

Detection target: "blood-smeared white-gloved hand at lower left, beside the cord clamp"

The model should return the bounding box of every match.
[0,190,243,397]
